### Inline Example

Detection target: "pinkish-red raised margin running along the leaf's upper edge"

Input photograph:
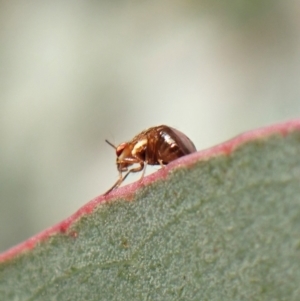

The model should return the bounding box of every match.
[0,119,300,263]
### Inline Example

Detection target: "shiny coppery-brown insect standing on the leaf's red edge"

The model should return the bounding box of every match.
[105,125,197,194]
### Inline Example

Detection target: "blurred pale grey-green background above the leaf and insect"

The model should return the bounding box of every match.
[0,0,300,251]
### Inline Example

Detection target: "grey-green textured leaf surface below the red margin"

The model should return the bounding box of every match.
[0,123,300,301]
